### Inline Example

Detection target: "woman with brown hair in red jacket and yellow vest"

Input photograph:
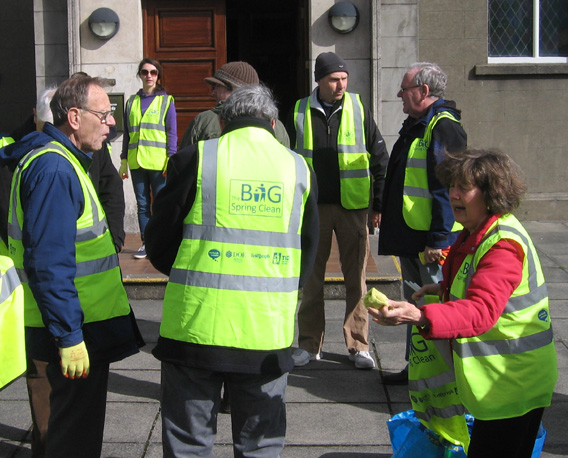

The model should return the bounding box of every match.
[369,150,558,458]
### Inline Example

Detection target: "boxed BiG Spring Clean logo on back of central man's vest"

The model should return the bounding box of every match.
[229,180,284,218]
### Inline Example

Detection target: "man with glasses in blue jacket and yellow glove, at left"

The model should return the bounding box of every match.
[0,78,141,458]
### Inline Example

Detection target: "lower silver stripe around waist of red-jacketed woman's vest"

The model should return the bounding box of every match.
[453,328,553,358]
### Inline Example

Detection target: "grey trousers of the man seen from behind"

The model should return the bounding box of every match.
[161,362,288,458]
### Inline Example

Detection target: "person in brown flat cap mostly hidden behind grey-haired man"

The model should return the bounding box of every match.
[179,61,290,149]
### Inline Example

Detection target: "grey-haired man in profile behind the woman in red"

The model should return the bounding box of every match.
[379,62,467,385]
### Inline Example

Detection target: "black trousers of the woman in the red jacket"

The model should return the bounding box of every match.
[467,407,544,458]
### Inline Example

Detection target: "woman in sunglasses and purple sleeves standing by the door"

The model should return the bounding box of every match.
[119,57,177,259]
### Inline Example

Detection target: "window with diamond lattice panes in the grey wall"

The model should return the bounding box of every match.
[489,0,568,63]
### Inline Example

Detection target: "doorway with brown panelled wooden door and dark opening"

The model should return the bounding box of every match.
[143,0,310,138]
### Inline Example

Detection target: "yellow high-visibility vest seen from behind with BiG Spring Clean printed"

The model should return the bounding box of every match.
[160,127,311,350]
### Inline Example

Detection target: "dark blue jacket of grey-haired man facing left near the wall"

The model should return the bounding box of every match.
[379,99,467,256]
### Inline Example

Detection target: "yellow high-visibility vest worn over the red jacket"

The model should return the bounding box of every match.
[450,215,558,420]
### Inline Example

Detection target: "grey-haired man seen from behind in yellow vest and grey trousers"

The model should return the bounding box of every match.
[146,85,318,458]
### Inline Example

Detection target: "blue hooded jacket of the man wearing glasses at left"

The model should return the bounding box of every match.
[0,123,141,362]
